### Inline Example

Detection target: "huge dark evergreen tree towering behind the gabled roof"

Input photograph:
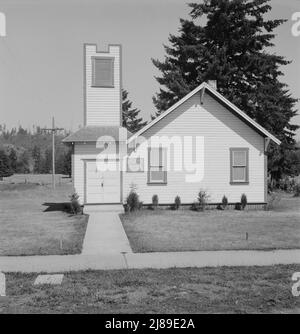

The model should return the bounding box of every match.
[153,0,298,178]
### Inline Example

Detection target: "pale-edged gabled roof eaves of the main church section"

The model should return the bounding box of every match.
[128,82,281,145]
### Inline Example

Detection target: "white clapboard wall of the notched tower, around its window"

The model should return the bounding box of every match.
[85,45,121,126]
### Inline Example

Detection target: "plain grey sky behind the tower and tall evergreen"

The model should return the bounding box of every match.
[0,0,300,139]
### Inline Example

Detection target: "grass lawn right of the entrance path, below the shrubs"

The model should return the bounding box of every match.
[121,195,300,252]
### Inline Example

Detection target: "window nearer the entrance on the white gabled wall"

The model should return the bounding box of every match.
[148,147,167,184]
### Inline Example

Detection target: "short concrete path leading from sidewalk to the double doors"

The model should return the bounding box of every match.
[82,206,132,255]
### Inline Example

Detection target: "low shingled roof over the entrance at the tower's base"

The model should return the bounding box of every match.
[63,126,132,143]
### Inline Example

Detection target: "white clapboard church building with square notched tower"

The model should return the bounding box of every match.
[64,44,280,204]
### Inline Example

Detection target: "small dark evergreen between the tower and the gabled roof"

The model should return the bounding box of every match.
[122,89,147,133]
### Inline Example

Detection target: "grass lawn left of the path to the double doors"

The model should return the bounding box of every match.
[0,175,88,256]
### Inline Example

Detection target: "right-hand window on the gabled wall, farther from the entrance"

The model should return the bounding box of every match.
[230,148,249,184]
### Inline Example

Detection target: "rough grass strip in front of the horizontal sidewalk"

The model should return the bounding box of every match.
[0,265,300,313]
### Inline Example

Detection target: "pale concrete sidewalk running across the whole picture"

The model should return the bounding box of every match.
[0,249,300,273]
